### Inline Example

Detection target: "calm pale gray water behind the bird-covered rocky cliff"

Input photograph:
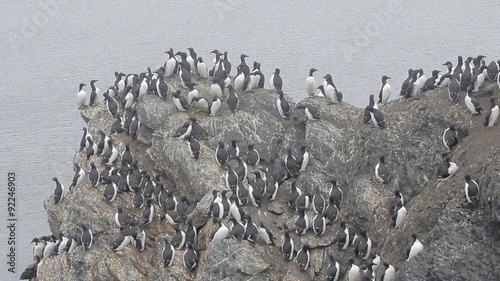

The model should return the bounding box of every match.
[0,0,500,280]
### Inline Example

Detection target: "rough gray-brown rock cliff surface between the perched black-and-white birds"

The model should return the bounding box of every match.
[32,72,500,281]
